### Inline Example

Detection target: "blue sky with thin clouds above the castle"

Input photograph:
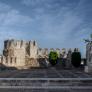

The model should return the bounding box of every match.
[0,0,92,55]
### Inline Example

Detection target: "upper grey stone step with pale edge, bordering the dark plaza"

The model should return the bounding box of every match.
[0,78,92,88]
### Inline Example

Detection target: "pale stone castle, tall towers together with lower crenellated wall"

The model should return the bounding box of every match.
[0,39,73,68]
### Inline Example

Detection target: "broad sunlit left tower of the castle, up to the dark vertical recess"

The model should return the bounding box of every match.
[3,40,26,67]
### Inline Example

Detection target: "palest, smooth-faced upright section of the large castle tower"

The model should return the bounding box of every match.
[14,40,26,67]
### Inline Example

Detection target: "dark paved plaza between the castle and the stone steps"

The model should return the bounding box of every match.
[0,67,92,78]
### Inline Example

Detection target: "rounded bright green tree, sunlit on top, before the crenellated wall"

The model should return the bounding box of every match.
[49,51,58,65]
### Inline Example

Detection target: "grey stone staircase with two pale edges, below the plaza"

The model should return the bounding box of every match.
[0,78,92,92]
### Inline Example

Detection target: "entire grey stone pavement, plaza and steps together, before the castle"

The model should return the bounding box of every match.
[0,67,92,92]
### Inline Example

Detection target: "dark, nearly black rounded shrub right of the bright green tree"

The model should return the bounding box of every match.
[71,52,81,67]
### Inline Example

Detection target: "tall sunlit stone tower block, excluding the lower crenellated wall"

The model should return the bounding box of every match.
[2,40,39,67]
